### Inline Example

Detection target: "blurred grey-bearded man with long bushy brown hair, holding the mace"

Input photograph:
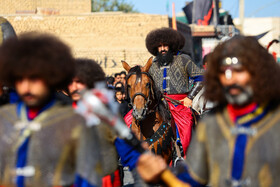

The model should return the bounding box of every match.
[138,36,280,186]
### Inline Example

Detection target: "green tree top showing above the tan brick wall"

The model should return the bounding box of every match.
[91,0,137,12]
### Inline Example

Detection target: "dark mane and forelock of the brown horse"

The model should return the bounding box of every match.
[126,65,171,122]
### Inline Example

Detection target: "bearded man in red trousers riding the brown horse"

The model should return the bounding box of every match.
[146,28,203,153]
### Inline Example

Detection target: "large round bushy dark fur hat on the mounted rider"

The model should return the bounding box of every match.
[146,27,185,56]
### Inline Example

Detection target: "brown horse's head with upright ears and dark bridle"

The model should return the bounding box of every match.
[122,57,154,121]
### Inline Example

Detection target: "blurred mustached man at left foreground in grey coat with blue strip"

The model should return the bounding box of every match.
[0,33,101,187]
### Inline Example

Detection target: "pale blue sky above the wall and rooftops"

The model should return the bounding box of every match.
[129,0,280,18]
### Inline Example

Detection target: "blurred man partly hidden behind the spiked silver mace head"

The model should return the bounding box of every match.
[68,58,121,187]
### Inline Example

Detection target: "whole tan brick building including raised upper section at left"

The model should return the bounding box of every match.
[0,0,192,75]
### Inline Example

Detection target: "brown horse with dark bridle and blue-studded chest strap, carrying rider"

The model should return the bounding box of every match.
[122,58,175,163]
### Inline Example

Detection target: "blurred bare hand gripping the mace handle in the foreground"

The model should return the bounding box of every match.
[137,153,167,183]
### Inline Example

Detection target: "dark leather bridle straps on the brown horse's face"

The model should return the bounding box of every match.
[126,72,156,119]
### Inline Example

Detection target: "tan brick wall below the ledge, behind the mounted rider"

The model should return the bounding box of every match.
[1,12,168,75]
